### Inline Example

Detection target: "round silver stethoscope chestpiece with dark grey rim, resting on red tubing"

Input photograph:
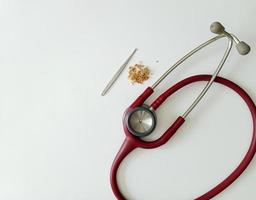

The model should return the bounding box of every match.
[127,105,156,137]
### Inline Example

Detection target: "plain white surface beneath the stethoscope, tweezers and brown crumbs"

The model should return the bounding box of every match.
[0,0,256,200]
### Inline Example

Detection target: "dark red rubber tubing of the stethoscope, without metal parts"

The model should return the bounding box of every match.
[110,75,256,200]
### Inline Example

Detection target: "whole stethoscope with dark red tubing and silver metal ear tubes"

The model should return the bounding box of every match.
[110,22,256,200]
